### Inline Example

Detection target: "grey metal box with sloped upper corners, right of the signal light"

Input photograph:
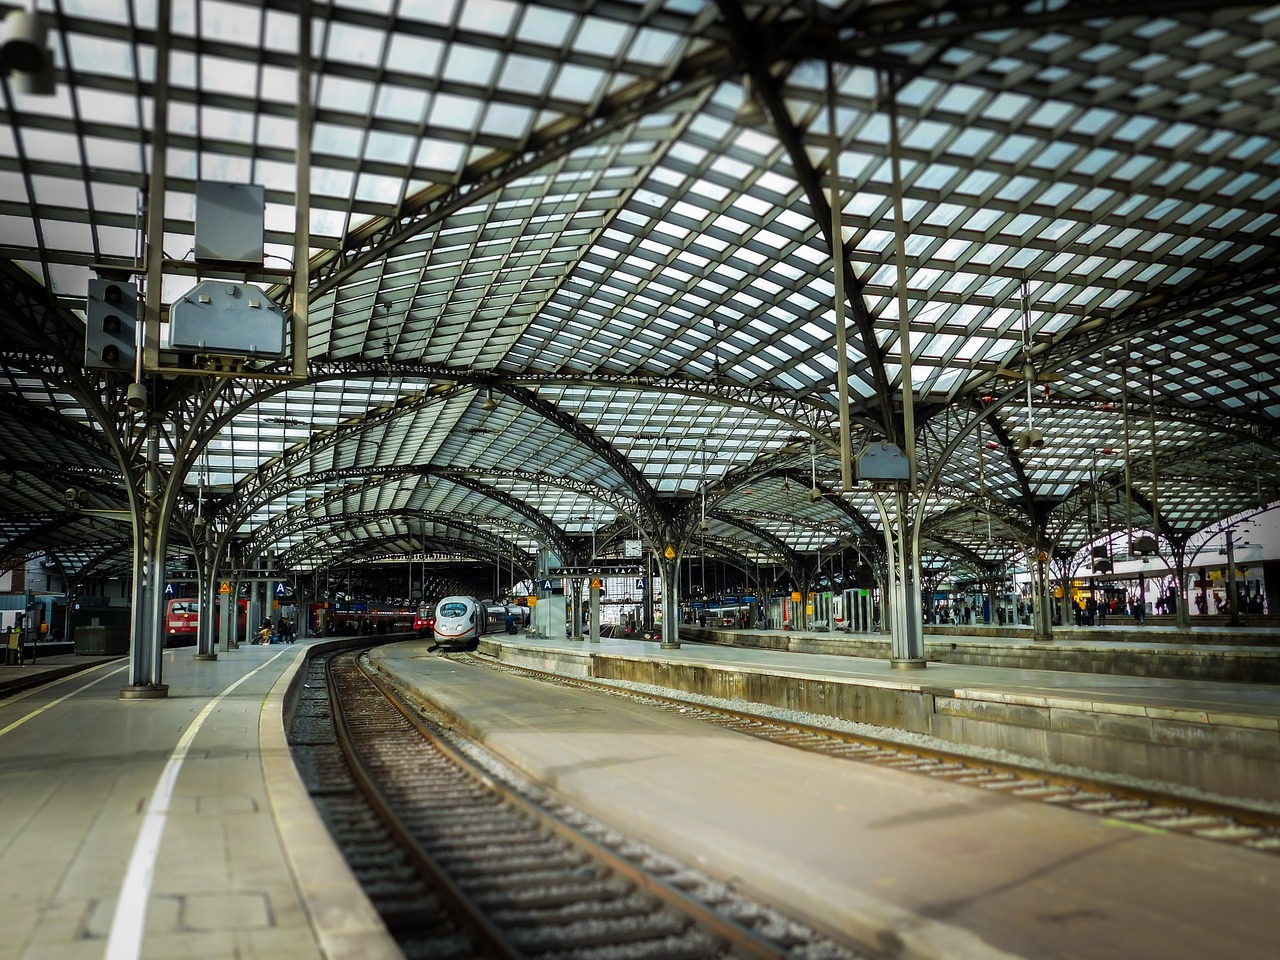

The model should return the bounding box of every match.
[169,280,285,357]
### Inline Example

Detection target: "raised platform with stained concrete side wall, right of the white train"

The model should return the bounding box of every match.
[480,635,1280,803]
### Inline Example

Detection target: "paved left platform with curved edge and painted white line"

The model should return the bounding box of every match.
[0,644,399,960]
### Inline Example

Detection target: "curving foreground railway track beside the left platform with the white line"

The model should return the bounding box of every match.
[291,652,858,960]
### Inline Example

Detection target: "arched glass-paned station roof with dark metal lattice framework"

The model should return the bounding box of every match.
[0,0,1280,586]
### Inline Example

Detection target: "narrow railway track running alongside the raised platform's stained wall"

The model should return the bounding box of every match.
[448,653,1280,854]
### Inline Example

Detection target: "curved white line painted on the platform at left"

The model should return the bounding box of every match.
[105,650,293,960]
